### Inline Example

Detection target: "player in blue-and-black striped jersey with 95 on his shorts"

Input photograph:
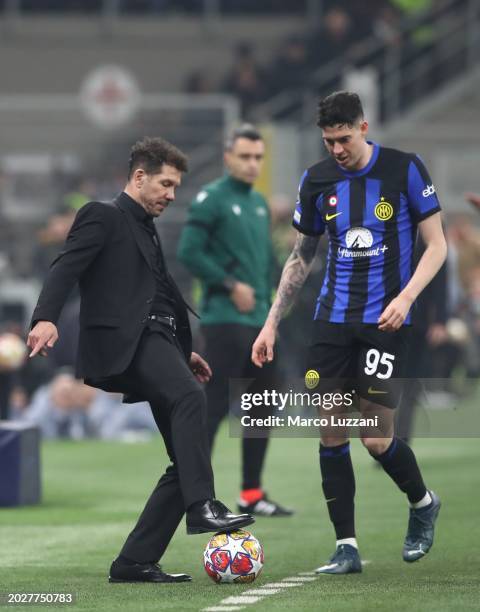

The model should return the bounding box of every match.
[252,91,446,574]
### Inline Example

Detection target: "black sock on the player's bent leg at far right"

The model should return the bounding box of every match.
[372,438,427,504]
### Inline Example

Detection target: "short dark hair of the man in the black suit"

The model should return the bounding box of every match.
[128,137,188,179]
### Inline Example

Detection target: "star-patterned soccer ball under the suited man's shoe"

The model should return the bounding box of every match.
[203,529,264,582]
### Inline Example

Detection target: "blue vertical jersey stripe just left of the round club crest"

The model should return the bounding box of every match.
[363,179,385,323]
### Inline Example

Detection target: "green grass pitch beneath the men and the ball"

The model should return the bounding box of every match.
[0,428,480,612]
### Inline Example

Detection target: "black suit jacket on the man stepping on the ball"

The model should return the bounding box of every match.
[32,194,195,392]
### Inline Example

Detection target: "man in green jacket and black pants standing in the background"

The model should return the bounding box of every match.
[178,125,292,516]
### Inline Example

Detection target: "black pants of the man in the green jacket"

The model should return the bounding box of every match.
[202,323,275,489]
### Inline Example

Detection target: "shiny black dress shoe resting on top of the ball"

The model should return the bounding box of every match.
[187,499,255,535]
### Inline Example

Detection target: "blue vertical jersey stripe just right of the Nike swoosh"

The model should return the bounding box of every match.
[329,181,353,323]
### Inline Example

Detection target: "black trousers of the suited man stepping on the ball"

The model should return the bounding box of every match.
[100,321,215,563]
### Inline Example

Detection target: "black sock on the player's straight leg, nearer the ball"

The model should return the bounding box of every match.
[320,442,355,540]
